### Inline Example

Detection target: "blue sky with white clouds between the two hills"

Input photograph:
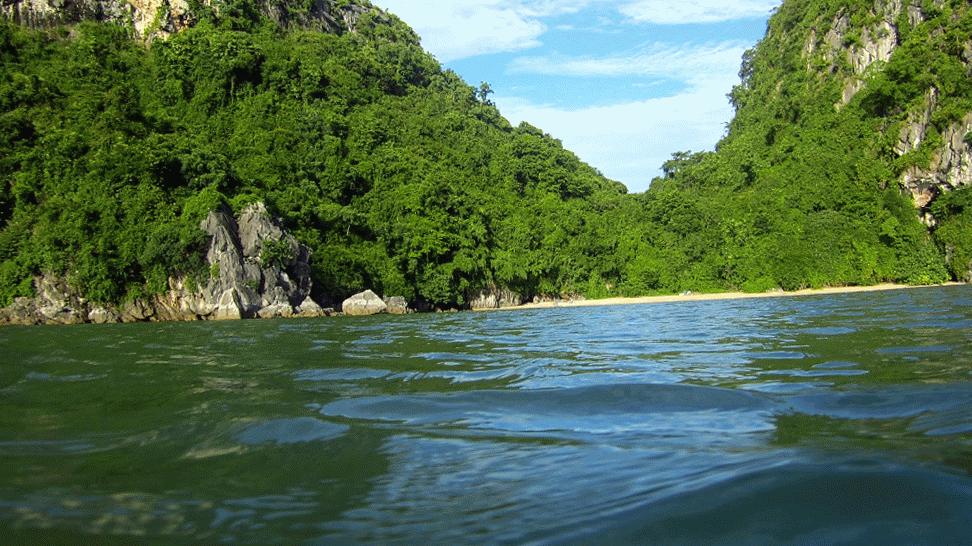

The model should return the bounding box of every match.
[372,0,780,192]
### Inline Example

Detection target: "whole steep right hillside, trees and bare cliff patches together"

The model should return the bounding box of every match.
[646,0,972,290]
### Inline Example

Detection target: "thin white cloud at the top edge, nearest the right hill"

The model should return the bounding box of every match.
[619,0,780,25]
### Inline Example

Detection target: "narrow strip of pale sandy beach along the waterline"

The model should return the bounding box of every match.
[499,283,962,311]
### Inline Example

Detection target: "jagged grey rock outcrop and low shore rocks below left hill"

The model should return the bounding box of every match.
[0,203,326,324]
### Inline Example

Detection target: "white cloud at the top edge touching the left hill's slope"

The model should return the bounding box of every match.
[374,0,591,62]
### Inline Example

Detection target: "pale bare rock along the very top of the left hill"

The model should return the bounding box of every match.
[0,0,378,40]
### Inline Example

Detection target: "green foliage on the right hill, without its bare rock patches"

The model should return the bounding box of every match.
[628,0,972,291]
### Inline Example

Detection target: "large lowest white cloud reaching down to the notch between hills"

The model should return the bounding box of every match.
[496,44,744,191]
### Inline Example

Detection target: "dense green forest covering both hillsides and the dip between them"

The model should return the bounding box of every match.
[0,0,972,307]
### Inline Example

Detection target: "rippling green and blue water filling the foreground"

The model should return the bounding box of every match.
[0,287,972,544]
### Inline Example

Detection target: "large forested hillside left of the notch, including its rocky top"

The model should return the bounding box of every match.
[0,0,624,316]
